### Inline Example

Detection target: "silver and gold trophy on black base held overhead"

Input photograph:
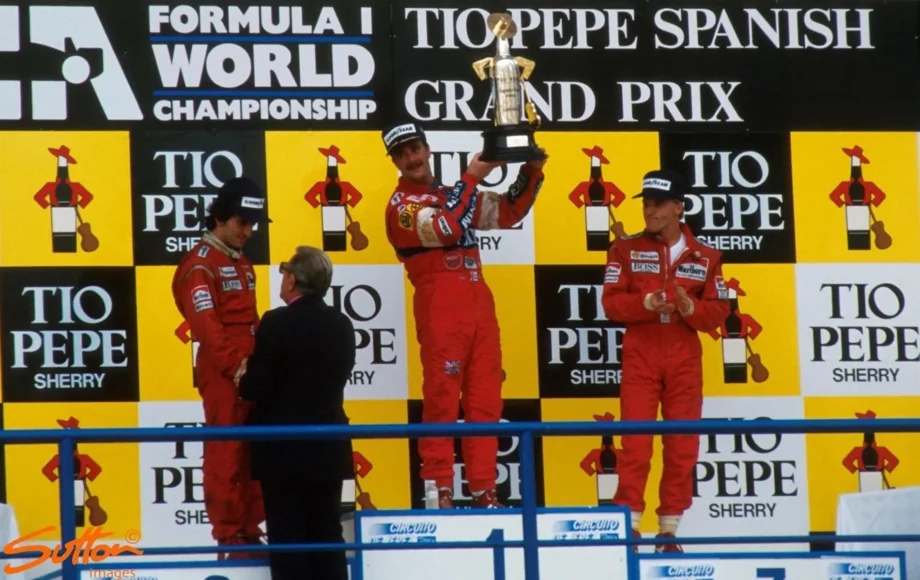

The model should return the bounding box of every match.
[473,13,545,163]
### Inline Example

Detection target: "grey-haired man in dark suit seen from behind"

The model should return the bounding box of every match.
[239,246,356,580]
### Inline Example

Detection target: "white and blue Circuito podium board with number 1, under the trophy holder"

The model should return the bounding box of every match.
[356,506,631,580]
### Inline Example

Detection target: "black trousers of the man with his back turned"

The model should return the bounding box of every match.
[261,478,348,580]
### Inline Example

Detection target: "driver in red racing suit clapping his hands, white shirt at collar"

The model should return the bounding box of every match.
[602,170,729,552]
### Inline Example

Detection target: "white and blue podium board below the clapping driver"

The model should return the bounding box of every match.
[639,552,907,580]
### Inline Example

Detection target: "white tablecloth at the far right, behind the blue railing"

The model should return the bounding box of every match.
[837,487,920,580]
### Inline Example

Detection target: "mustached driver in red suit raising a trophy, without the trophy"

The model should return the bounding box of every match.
[383,123,546,508]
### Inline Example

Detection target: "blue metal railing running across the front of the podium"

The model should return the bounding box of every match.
[0,419,920,580]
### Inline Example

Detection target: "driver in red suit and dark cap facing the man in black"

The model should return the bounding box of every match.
[172,178,270,559]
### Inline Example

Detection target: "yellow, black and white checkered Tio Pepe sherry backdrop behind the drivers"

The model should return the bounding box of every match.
[0,2,920,549]
